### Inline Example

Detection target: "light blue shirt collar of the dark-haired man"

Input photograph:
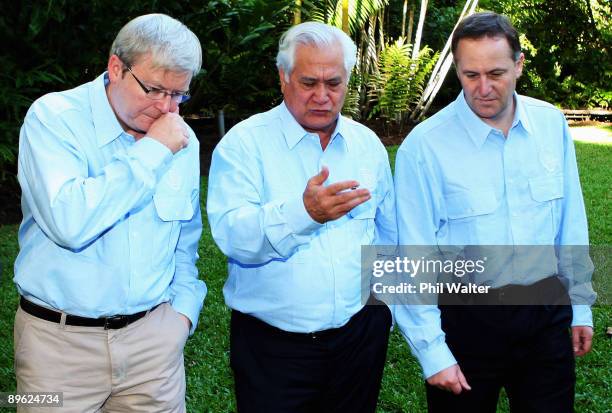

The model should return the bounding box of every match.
[455,91,531,149]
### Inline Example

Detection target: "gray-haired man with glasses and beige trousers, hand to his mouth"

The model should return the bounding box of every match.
[15,14,206,412]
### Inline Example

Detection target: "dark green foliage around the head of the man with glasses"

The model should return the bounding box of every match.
[0,0,294,181]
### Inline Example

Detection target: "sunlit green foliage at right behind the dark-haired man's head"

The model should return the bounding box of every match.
[480,0,612,109]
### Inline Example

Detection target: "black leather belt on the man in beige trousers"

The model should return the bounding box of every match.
[19,297,159,330]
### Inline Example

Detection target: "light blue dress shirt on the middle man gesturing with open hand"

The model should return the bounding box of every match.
[207,103,397,333]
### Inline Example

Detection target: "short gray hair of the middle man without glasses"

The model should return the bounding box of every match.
[276,22,357,83]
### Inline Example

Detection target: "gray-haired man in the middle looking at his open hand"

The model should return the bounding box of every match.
[207,23,397,413]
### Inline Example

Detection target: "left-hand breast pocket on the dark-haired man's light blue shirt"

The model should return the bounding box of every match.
[445,190,499,245]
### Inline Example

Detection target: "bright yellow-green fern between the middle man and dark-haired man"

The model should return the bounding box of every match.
[370,38,438,124]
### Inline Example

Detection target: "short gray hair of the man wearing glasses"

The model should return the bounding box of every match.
[110,14,202,76]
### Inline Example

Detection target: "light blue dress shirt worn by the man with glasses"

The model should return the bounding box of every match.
[15,74,206,332]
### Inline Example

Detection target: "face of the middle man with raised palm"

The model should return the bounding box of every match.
[279,44,347,133]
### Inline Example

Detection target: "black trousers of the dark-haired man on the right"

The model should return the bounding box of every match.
[426,305,576,413]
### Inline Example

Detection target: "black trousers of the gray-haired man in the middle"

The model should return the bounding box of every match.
[230,305,391,413]
